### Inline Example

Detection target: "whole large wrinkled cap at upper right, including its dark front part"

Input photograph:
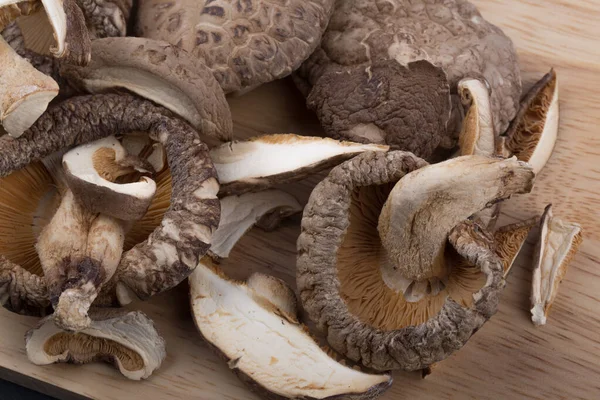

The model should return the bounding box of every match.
[296,0,521,158]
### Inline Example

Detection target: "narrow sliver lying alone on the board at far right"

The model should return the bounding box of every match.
[531,205,583,325]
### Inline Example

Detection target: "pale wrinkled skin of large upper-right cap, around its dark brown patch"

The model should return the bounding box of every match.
[296,0,521,157]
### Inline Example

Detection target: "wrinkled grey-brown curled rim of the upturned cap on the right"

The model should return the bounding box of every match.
[297,151,504,371]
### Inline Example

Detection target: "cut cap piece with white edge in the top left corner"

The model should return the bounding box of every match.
[0,0,90,65]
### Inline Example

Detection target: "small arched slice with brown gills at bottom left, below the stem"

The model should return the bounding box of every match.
[25,309,166,380]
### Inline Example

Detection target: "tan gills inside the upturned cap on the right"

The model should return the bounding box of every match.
[337,183,486,331]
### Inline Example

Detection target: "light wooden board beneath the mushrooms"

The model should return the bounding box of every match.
[0,0,600,400]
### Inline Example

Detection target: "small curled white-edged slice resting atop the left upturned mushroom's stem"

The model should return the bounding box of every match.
[63,136,156,221]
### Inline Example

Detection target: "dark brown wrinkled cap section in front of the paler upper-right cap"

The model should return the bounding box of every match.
[307,60,451,157]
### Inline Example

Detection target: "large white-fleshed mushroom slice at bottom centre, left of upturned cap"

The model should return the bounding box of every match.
[190,257,392,399]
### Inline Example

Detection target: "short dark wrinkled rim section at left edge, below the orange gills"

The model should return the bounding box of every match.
[0,256,50,316]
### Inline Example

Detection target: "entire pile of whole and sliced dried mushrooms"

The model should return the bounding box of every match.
[0,0,582,399]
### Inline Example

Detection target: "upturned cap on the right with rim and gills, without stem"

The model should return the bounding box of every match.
[297,151,504,371]
